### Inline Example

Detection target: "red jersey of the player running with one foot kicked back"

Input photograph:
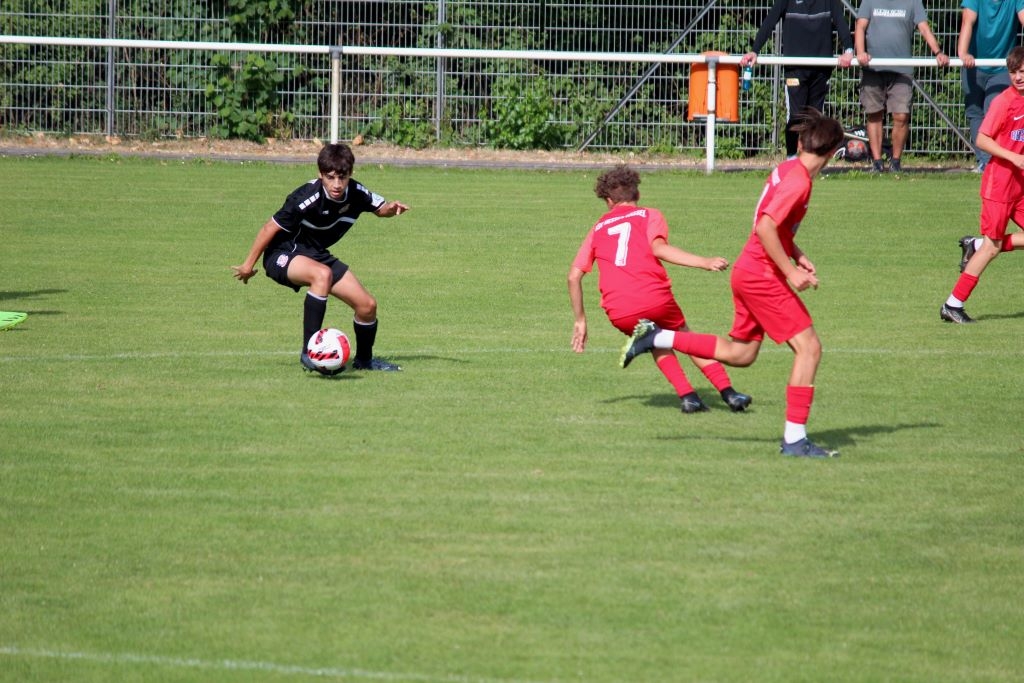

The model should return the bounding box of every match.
[733,159,811,278]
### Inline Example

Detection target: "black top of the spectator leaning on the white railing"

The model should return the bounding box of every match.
[753,0,853,57]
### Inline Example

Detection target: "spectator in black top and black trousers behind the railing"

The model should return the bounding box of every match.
[739,0,853,158]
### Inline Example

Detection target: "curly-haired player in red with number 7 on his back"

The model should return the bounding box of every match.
[568,166,752,413]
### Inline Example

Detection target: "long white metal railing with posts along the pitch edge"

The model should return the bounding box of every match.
[0,35,1006,173]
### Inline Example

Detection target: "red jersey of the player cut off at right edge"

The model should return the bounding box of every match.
[979,86,1024,202]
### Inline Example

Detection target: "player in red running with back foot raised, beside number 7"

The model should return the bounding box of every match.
[620,110,843,458]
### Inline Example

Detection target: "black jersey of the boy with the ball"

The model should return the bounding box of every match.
[266,178,385,253]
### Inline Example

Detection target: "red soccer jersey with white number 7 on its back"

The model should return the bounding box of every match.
[572,206,672,317]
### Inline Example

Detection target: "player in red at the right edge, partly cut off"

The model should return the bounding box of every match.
[939,47,1024,325]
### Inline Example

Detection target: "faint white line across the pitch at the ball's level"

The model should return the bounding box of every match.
[0,344,1006,365]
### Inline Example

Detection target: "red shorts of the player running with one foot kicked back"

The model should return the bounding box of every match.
[729,268,813,344]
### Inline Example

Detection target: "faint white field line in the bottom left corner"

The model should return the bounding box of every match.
[0,645,548,683]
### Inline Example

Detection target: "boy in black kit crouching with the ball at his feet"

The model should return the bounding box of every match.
[231,144,409,375]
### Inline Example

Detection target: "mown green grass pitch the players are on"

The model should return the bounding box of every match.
[0,158,1024,683]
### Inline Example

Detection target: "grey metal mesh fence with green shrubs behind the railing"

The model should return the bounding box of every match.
[0,0,970,160]
